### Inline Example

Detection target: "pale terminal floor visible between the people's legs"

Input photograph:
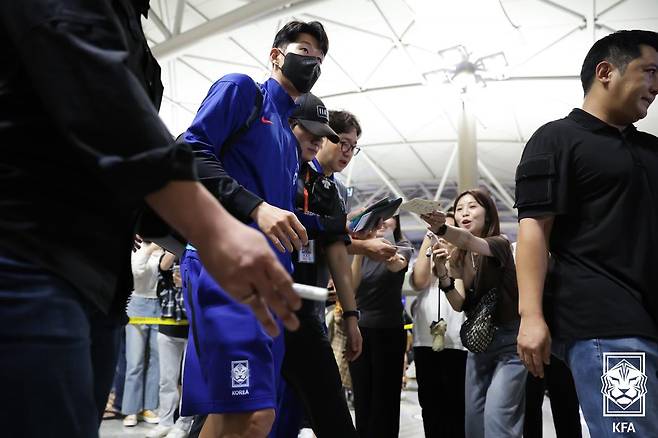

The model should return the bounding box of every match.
[100,379,589,438]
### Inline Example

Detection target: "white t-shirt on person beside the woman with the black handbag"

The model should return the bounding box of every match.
[412,278,466,350]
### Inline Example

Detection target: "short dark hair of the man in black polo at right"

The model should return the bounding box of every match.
[580,30,658,94]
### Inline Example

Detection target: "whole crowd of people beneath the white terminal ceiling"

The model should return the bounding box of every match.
[0,0,658,438]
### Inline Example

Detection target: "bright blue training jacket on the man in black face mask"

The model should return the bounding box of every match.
[184,74,299,272]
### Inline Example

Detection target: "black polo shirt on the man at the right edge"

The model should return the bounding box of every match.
[516,109,658,339]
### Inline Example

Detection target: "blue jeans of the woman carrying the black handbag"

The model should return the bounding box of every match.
[466,323,528,438]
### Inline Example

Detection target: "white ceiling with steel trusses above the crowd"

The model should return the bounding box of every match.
[144,0,658,240]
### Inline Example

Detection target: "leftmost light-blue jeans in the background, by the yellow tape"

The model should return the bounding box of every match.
[121,295,160,415]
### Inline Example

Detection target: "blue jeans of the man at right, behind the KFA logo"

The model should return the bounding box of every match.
[553,337,658,438]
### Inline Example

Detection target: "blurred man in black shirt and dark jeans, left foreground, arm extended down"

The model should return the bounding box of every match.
[0,0,300,438]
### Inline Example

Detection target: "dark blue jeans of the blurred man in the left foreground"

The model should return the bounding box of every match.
[0,249,120,438]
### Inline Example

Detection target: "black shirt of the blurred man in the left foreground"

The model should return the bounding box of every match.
[0,0,195,312]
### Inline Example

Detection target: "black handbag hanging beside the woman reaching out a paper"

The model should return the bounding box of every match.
[459,288,498,353]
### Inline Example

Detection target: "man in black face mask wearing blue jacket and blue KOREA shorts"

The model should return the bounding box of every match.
[182,21,328,437]
